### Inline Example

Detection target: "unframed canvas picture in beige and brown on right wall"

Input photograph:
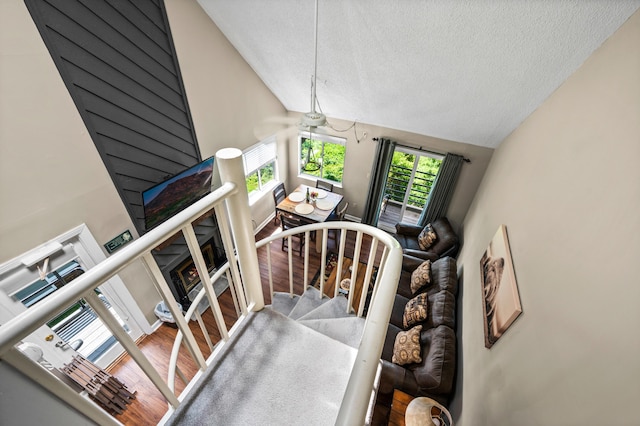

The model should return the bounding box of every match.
[480,225,522,348]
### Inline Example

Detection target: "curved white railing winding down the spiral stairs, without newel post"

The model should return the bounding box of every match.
[168,222,402,425]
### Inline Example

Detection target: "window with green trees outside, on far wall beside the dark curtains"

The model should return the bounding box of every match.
[298,133,346,184]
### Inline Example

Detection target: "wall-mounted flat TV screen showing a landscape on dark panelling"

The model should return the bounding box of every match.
[142,157,213,231]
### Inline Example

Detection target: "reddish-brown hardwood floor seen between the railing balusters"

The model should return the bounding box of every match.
[109,222,390,426]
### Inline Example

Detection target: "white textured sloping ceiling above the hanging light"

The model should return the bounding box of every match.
[199,0,640,147]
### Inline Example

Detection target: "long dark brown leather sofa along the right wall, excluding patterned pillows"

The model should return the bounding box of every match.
[372,255,458,425]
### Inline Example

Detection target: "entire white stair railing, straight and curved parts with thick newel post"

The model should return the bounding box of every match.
[0,149,402,425]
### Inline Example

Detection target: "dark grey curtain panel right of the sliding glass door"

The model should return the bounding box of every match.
[418,153,464,226]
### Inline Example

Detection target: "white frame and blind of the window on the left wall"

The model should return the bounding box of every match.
[242,135,280,205]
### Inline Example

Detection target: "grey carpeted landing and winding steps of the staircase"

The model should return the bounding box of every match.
[166,287,364,425]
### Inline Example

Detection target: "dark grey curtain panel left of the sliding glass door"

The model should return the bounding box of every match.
[362,138,396,226]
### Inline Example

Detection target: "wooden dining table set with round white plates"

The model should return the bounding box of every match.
[276,184,344,253]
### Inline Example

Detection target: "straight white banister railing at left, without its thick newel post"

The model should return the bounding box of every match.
[0,171,240,424]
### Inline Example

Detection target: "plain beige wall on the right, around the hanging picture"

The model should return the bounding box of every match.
[451,12,640,426]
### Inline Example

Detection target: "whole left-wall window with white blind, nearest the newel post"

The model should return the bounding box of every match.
[242,136,279,199]
